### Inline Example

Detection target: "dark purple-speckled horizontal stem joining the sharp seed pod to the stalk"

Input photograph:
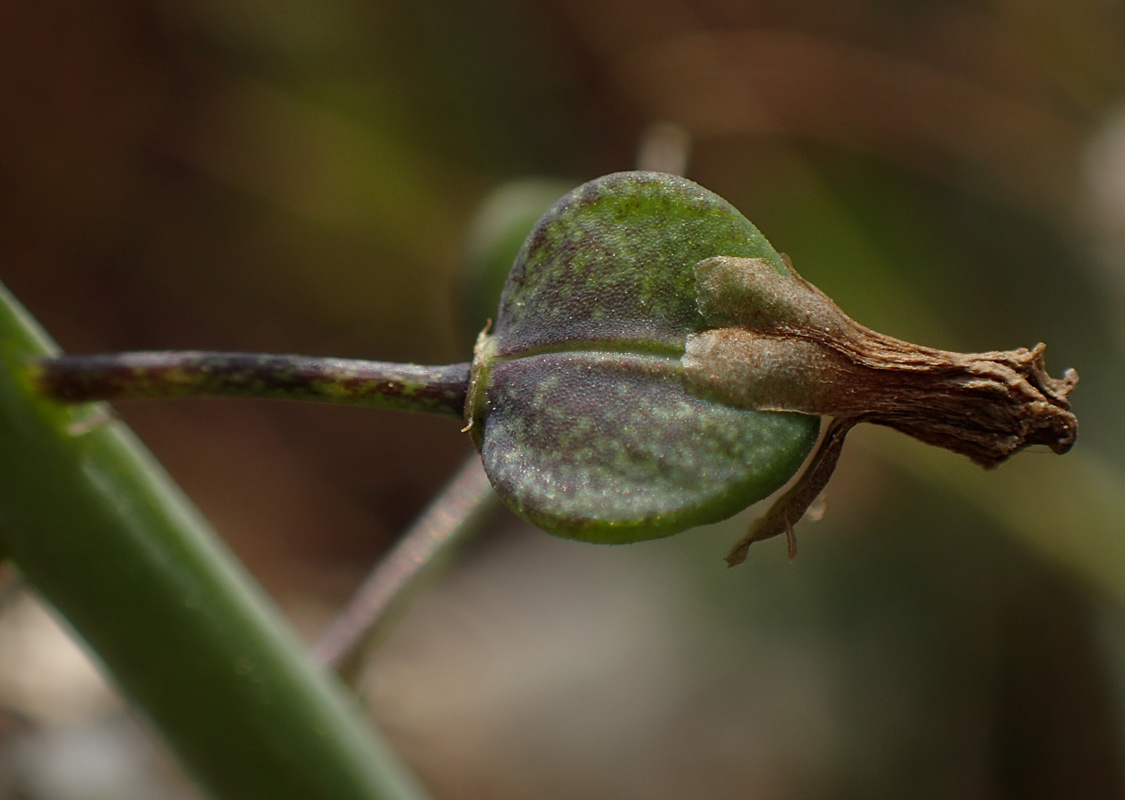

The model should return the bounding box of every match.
[32,351,469,419]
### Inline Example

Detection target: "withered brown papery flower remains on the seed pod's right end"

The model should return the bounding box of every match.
[683,258,1078,564]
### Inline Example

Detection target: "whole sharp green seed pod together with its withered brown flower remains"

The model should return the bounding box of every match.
[466,172,1078,565]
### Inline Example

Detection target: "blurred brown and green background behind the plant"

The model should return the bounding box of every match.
[0,0,1125,800]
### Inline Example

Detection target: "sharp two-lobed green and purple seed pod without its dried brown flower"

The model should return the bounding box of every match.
[466,172,819,543]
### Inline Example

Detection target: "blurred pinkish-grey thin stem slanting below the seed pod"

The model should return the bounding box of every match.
[313,455,500,676]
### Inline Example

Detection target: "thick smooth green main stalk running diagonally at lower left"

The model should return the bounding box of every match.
[0,281,424,800]
